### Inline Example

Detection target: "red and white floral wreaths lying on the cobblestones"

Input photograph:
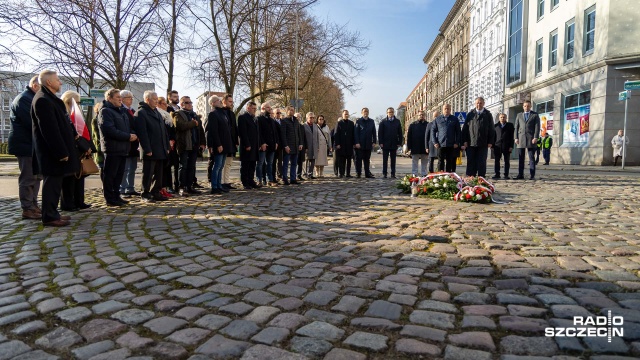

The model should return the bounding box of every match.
[398,172,496,204]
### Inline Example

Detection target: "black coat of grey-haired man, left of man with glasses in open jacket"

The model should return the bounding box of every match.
[134,102,169,160]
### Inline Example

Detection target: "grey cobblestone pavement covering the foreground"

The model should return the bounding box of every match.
[0,174,640,360]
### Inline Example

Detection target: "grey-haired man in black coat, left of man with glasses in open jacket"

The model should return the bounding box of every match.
[134,90,170,202]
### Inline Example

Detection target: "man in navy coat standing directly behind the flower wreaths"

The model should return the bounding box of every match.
[431,104,462,172]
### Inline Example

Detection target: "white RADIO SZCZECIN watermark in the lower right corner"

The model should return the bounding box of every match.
[544,310,624,342]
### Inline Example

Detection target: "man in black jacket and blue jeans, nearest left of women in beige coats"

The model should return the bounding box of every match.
[280,106,304,185]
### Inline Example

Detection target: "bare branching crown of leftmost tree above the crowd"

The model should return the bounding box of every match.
[0,0,162,88]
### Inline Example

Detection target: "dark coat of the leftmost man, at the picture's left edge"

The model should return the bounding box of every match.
[8,86,36,157]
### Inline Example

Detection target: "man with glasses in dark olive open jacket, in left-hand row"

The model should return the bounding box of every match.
[171,96,206,196]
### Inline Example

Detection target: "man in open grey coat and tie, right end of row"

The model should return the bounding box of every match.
[515,100,540,180]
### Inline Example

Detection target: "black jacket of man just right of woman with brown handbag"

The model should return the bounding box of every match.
[98,100,131,156]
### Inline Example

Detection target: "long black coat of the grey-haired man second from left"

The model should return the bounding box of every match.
[31,86,80,176]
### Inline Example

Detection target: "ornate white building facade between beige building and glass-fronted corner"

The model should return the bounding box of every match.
[467,0,507,114]
